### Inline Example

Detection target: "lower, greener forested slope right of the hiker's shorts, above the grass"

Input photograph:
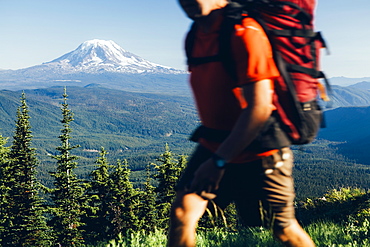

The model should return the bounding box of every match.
[293,139,370,200]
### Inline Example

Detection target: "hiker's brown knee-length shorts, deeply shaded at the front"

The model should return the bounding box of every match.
[176,145,295,229]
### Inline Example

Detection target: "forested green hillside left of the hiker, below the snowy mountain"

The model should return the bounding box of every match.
[0,87,197,167]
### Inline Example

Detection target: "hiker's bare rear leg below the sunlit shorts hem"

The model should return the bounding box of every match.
[274,220,315,247]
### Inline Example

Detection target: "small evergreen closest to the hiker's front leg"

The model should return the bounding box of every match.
[153,144,186,228]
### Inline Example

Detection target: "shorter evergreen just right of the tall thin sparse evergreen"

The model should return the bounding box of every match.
[83,147,113,242]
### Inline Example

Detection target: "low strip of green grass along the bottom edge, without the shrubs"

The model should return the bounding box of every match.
[90,222,370,247]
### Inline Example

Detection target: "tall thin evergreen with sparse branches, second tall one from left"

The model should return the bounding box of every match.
[51,89,84,246]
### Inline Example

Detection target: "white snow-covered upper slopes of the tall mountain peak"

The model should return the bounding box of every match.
[43,39,185,74]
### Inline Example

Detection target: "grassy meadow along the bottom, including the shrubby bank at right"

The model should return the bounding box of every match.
[90,188,370,247]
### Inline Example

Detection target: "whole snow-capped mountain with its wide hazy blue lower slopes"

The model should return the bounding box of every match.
[0,39,188,92]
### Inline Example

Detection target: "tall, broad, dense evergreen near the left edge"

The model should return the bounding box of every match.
[1,93,50,246]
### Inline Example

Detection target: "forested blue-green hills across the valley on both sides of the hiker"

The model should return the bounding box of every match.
[0,85,370,198]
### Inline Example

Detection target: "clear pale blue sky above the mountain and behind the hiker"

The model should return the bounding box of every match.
[0,0,370,77]
